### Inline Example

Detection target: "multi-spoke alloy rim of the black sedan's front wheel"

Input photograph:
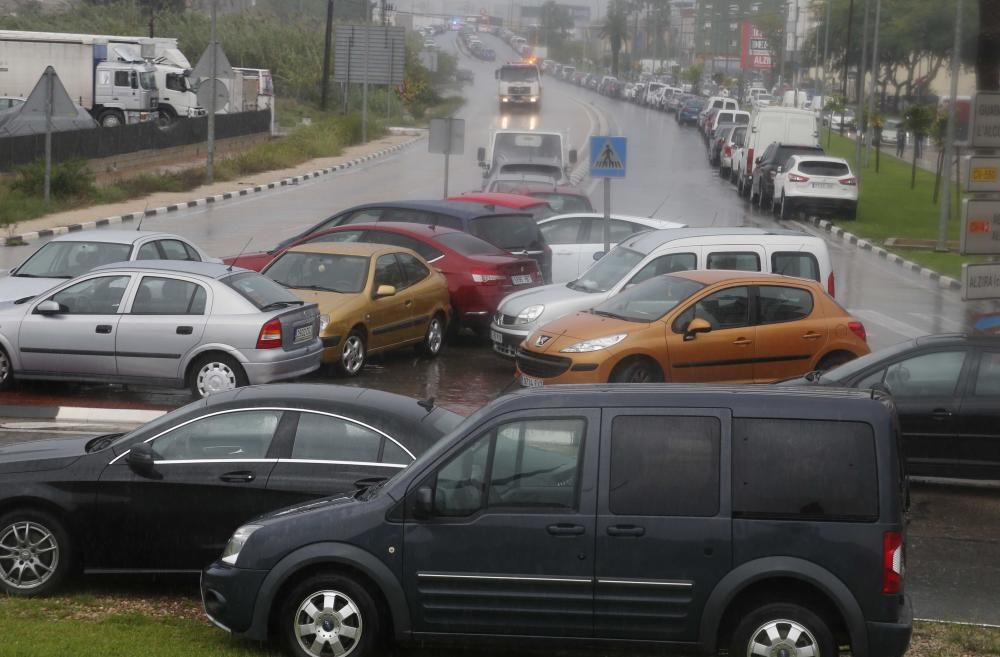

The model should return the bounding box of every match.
[0,520,59,591]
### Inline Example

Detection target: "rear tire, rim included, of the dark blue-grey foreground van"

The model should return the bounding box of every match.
[729,602,837,657]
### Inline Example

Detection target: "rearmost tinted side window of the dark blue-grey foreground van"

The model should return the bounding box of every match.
[733,418,878,521]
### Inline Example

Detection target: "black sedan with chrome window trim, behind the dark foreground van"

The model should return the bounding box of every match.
[0,384,463,595]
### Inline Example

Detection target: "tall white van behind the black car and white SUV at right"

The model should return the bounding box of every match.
[733,107,819,197]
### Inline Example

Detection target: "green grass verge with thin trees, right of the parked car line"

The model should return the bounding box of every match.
[822,130,986,278]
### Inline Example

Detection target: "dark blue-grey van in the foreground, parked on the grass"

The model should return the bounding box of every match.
[201,386,912,657]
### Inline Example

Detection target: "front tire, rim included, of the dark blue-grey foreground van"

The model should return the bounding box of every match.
[279,573,381,657]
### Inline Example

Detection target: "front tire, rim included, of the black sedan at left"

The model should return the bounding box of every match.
[0,509,73,597]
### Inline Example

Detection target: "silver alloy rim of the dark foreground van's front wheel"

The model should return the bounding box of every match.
[294,591,364,657]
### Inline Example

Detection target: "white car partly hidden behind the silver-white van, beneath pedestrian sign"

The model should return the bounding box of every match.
[538,213,687,283]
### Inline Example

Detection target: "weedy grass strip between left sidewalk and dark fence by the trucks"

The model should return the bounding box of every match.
[0,110,385,232]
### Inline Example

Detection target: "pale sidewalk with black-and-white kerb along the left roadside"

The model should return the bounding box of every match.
[4,135,421,234]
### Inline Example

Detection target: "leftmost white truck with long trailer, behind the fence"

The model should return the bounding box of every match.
[0,30,159,128]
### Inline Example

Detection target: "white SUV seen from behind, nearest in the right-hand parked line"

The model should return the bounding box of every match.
[771,155,858,219]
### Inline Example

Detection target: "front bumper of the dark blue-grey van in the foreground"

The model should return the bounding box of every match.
[201,561,267,640]
